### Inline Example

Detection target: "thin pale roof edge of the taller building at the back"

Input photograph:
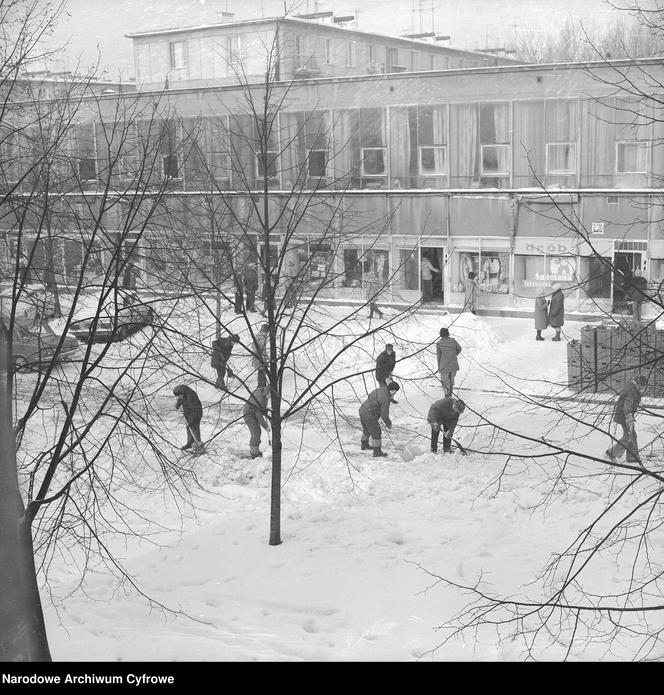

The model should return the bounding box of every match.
[125,17,521,64]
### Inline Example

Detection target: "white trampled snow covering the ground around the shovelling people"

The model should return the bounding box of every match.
[19,307,664,661]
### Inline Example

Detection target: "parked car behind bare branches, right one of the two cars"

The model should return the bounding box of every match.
[69,289,155,343]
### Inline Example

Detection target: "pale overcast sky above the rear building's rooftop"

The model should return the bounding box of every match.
[45,0,620,77]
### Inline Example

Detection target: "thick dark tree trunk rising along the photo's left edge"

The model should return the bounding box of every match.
[0,321,51,661]
